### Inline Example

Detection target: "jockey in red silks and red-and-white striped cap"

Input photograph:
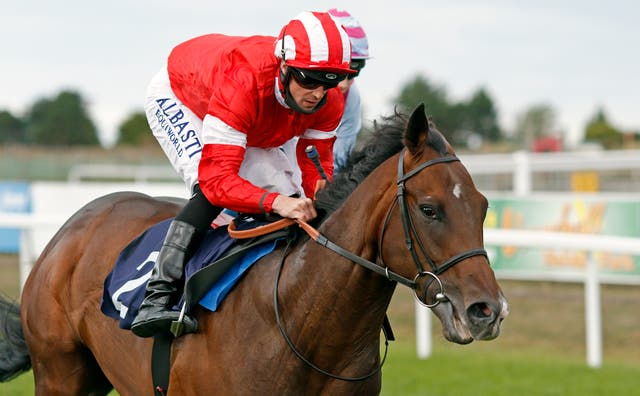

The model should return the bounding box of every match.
[131,12,356,337]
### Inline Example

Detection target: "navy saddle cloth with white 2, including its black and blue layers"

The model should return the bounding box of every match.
[101,219,284,329]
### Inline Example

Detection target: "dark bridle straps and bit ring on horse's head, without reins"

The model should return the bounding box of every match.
[378,148,487,308]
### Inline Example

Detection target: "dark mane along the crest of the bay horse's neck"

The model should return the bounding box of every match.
[315,111,447,222]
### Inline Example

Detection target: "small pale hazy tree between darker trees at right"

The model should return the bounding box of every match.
[514,103,556,147]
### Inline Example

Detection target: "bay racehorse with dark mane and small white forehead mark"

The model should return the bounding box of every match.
[0,105,508,395]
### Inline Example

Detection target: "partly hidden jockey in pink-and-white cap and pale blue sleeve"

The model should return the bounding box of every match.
[328,8,369,172]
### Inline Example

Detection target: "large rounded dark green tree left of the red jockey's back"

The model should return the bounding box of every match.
[26,91,100,146]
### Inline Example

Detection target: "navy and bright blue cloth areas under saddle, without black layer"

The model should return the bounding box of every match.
[100,219,277,329]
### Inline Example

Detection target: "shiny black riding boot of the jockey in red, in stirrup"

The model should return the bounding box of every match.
[131,220,198,337]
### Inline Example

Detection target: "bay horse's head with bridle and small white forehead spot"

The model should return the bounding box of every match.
[379,105,508,344]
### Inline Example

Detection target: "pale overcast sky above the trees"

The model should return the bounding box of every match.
[0,0,640,146]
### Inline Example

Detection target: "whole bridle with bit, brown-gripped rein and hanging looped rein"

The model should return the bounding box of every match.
[273,148,487,381]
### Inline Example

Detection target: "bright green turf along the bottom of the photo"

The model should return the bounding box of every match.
[0,342,640,396]
